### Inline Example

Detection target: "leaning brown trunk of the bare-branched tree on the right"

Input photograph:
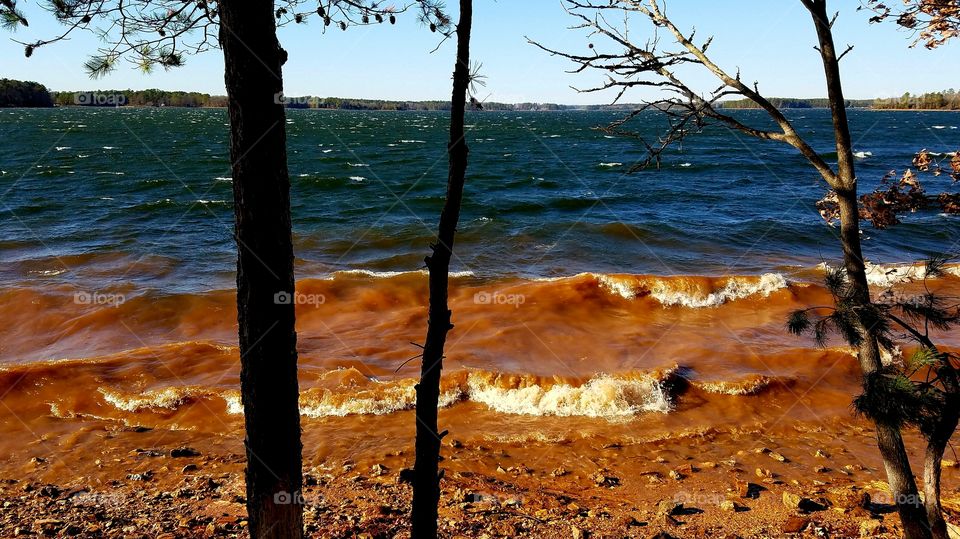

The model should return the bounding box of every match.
[803,0,931,539]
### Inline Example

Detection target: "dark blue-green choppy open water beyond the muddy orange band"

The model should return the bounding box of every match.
[0,108,960,291]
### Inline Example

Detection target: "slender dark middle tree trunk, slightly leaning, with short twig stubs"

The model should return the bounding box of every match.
[411,0,473,539]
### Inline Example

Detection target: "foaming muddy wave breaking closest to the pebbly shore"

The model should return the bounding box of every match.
[88,366,793,421]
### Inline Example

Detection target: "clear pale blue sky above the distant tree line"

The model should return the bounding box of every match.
[0,0,960,104]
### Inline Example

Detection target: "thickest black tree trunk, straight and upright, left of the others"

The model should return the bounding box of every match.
[219,0,303,539]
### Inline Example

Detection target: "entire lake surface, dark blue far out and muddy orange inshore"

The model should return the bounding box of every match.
[0,108,960,477]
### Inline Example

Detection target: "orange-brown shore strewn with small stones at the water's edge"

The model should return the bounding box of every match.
[0,425,960,538]
